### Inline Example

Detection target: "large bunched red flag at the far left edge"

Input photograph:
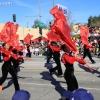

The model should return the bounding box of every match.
[0,22,19,46]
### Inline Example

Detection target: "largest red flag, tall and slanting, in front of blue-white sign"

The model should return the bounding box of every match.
[50,6,76,51]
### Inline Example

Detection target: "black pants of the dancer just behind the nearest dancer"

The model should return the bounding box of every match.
[50,57,62,75]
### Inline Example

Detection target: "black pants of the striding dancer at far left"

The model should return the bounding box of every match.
[0,61,20,91]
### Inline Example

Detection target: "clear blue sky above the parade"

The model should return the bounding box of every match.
[0,0,100,27]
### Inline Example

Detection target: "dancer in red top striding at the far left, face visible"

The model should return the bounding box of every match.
[0,43,20,91]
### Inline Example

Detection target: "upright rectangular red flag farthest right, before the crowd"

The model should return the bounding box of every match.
[80,26,89,45]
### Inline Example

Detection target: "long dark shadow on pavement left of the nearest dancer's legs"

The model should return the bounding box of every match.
[40,71,65,100]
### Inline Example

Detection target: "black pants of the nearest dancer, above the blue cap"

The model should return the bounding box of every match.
[64,67,78,91]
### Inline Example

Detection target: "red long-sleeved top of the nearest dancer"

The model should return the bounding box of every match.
[61,54,85,64]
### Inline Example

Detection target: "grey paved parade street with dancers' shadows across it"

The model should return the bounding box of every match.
[0,56,100,100]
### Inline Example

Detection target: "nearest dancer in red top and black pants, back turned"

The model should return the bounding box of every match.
[61,44,92,100]
